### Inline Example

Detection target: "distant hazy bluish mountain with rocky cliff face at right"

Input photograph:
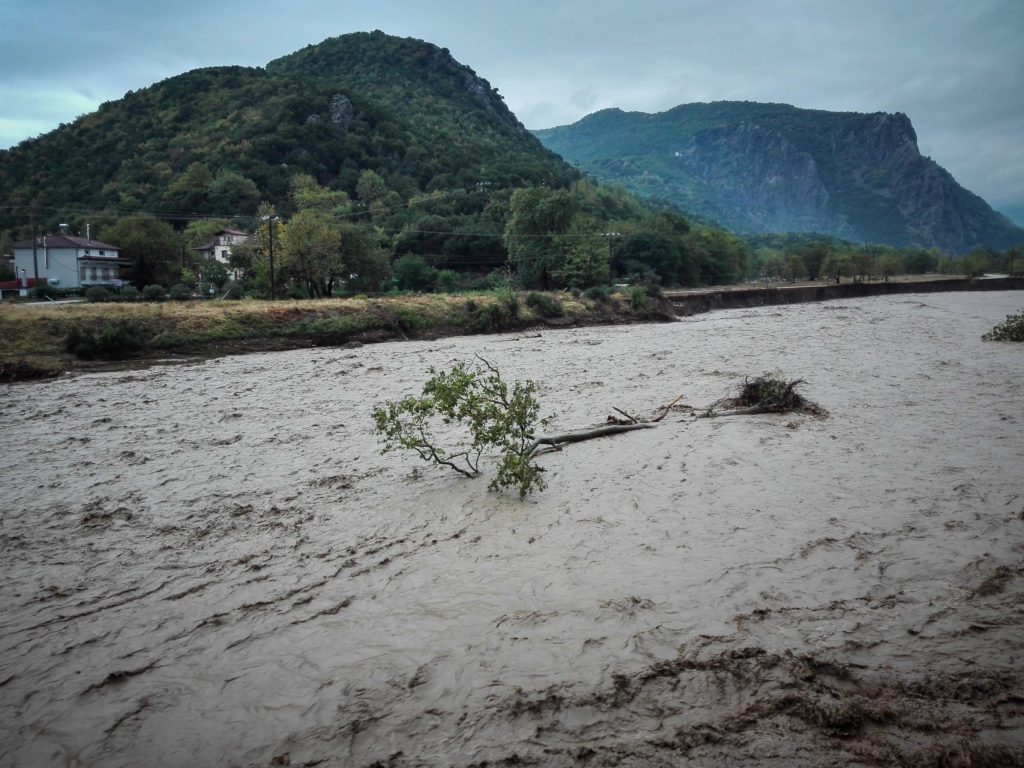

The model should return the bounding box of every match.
[534,101,1024,254]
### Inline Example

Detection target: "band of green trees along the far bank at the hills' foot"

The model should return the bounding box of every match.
[8,163,1024,298]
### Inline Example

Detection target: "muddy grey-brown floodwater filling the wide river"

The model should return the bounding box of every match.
[0,292,1024,768]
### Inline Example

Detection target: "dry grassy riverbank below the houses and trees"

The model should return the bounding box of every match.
[0,294,672,381]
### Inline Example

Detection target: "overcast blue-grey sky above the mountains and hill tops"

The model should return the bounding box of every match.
[0,0,1024,223]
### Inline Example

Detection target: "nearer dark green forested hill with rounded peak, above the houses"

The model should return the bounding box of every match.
[0,32,569,229]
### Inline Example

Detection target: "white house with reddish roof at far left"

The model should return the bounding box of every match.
[12,233,130,288]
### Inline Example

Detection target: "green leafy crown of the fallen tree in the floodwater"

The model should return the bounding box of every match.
[373,358,550,498]
